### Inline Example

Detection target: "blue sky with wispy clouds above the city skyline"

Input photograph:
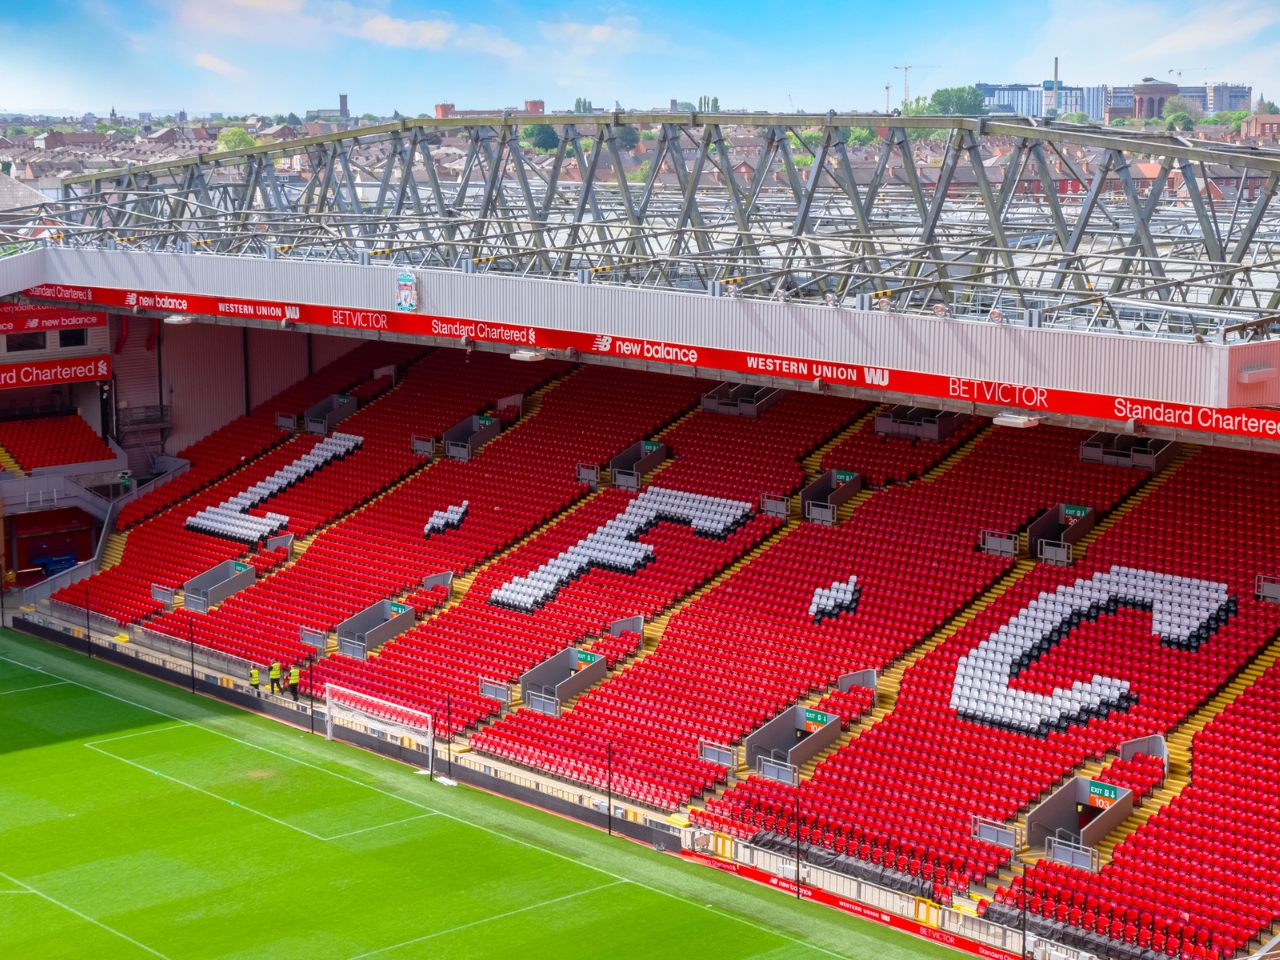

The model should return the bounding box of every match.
[0,0,1280,115]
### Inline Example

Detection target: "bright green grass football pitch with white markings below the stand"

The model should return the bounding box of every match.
[0,631,955,960]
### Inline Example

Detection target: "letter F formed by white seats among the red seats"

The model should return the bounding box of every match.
[489,486,751,612]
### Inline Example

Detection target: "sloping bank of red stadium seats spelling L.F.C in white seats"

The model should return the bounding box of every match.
[24,358,1280,960]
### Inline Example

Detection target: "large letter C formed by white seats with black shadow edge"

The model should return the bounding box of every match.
[951,567,1235,736]
